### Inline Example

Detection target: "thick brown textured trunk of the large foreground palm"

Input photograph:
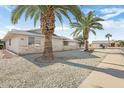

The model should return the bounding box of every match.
[43,5,55,60]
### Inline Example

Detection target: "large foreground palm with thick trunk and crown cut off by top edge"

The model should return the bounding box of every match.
[11,5,81,60]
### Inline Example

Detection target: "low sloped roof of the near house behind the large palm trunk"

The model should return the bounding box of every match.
[3,29,78,42]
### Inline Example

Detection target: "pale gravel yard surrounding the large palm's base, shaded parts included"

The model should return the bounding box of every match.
[0,50,106,88]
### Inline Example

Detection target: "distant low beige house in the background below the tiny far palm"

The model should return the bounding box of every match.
[92,40,115,48]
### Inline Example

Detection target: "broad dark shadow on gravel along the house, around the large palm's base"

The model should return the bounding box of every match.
[21,51,100,67]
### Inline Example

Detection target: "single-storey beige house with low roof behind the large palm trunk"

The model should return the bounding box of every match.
[4,29,79,54]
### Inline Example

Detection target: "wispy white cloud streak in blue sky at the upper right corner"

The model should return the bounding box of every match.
[100,8,124,19]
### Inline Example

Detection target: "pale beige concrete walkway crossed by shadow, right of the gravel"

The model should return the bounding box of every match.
[79,49,124,88]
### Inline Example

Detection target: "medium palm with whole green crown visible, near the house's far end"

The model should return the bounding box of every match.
[71,11,104,51]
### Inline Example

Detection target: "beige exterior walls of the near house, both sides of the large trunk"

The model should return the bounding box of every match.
[6,35,79,54]
